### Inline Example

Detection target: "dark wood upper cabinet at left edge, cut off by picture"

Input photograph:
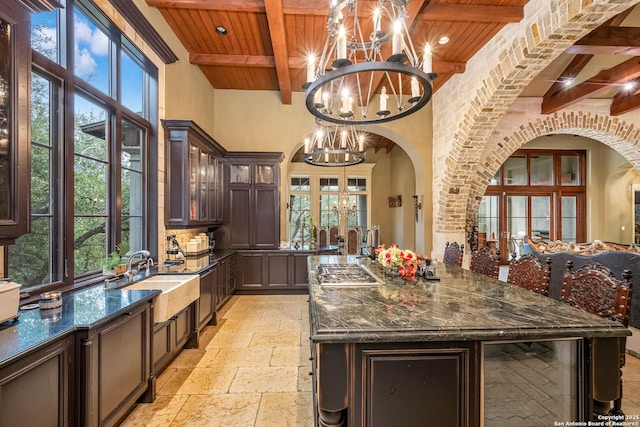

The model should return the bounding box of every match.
[0,0,59,245]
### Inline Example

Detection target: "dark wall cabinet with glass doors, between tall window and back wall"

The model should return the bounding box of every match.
[162,120,226,227]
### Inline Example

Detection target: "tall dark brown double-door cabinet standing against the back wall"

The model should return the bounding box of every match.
[223,152,283,249]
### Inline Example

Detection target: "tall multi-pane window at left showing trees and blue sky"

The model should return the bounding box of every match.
[8,0,158,290]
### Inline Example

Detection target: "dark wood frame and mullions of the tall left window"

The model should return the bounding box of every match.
[5,0,159,295]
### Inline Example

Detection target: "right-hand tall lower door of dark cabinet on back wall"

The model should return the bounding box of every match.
[253,188,280,248]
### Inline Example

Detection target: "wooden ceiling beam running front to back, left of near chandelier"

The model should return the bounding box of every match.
[264,0,291,105]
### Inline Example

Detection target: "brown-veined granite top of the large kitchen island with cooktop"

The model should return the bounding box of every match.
[309,255,631,343]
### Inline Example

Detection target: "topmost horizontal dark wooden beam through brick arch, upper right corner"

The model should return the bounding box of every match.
[566,27,640,56]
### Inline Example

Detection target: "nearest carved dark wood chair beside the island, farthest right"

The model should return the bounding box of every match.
[560,261,631,415]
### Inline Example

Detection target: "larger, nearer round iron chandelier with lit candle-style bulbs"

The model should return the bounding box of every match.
[303,0,436,124]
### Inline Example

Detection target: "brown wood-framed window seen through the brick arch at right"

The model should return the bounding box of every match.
[478,150,586,260]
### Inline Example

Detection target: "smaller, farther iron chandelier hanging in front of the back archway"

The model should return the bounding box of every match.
[304,119,365,167]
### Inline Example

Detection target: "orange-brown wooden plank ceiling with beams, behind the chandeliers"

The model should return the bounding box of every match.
[146,0,640,149]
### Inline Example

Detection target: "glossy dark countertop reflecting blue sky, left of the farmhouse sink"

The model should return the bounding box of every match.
[0,285,160,366]
